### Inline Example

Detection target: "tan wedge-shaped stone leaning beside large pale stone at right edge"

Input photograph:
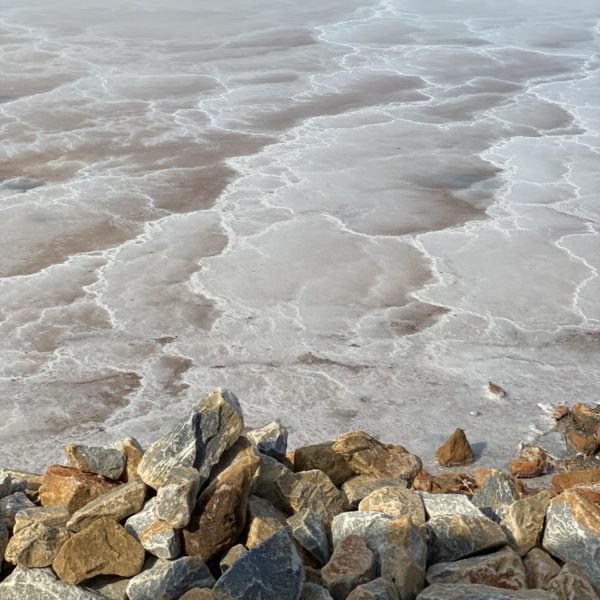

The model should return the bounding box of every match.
[500,490,552,556]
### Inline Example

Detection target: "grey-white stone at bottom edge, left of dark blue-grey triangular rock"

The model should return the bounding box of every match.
[127,556,215,600]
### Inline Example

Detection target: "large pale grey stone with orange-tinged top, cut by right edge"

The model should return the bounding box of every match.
[542,490,600,588]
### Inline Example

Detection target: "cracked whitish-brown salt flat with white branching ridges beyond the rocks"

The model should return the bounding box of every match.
[0,0,600,469]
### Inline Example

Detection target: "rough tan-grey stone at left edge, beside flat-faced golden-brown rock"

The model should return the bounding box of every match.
[5,523,70,568]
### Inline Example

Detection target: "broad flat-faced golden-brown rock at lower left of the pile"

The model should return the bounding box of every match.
[52,518,145,585]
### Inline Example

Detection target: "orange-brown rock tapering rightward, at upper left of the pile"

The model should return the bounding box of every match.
[39,465,119,513]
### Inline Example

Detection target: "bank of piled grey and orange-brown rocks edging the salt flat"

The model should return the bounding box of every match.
[0,389,600,600]
